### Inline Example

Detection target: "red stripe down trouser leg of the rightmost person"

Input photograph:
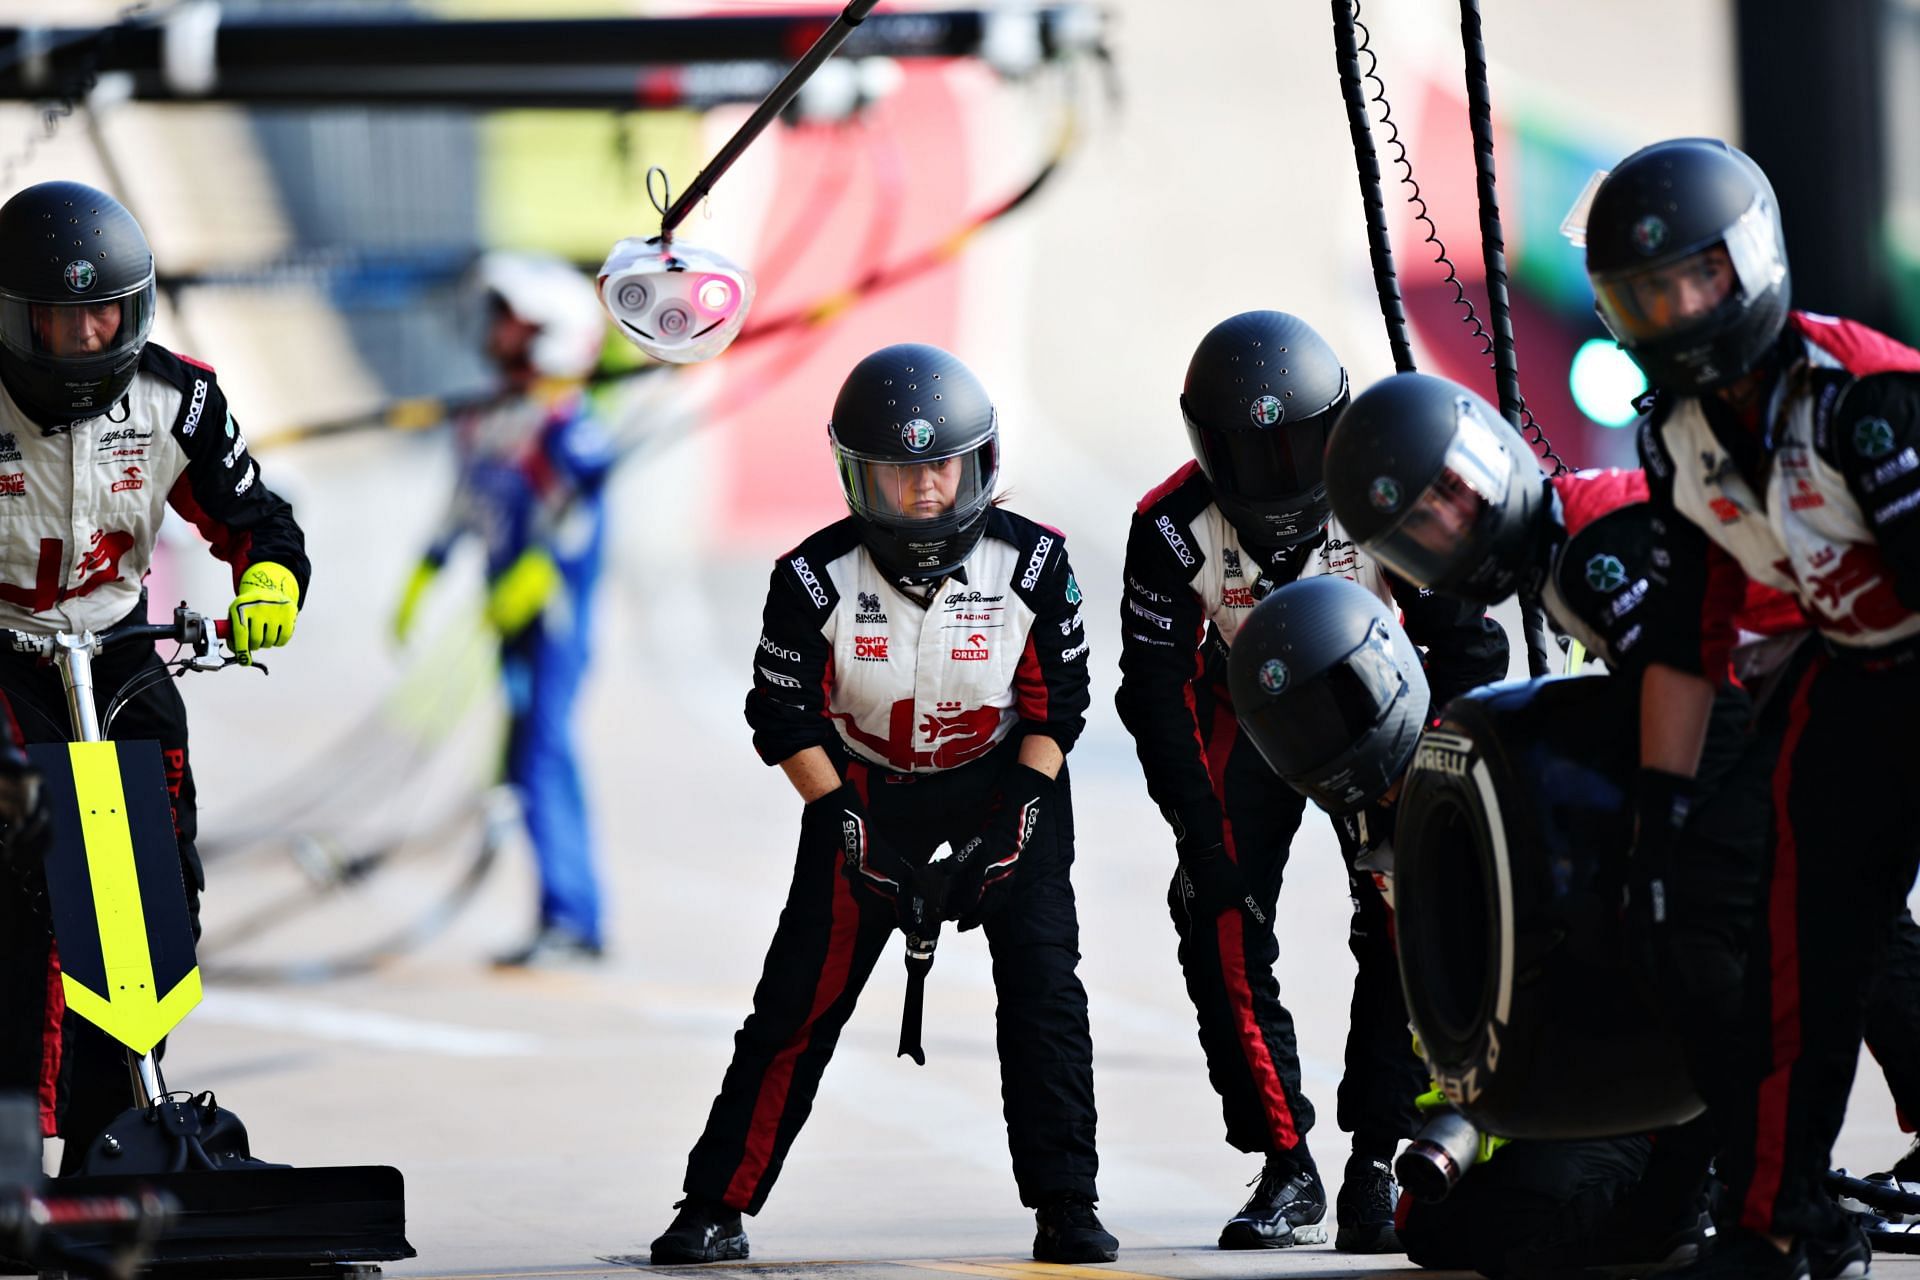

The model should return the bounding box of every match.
[1740,660,1826,1232]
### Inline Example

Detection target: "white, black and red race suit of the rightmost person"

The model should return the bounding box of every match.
[1640,313,1920,1236]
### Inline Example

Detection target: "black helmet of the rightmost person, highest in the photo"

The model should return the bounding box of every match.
[1584,138,1791,395]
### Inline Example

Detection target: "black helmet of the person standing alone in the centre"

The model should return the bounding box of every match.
[828,342,1000,581]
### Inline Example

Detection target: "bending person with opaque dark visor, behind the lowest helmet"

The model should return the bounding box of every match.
[1116,311,1507,1253]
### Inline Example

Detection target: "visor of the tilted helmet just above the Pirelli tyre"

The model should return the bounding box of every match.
[1367,401,1513,587]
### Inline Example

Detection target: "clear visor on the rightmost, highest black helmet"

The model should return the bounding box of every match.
[1594,203,1786,347]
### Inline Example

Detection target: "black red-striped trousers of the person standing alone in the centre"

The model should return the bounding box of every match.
[685,743,1098,1213]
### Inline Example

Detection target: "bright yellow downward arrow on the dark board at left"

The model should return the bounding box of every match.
[60,743,200,1054]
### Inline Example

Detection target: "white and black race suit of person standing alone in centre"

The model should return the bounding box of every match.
[685,509,1098,1213]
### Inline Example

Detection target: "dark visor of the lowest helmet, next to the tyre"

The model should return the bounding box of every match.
[1256,620,1407,779]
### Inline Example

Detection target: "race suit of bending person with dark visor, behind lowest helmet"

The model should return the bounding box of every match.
[1116,462,1507,1159]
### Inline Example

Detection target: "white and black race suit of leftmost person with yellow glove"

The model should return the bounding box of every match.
[0,342,309,1165]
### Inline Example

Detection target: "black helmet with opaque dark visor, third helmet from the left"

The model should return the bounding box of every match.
[1181,311,1348,549]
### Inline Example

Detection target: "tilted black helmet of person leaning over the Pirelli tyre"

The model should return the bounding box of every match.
[1327,372,1551,604]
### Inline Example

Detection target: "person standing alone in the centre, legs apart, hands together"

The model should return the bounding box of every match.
[653,344,1117,1263]
